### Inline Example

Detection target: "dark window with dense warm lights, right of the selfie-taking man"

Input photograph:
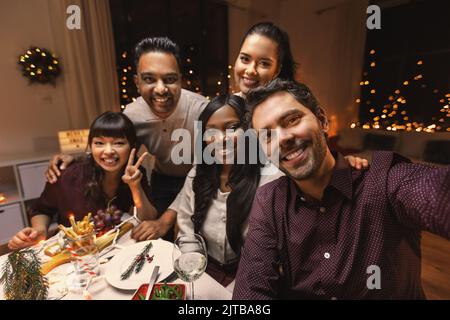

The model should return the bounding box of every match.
[356,0,450,132]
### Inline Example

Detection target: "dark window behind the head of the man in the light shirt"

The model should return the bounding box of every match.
[110,0,229,107]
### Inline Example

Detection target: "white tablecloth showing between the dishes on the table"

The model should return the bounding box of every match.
[0,232,232,300]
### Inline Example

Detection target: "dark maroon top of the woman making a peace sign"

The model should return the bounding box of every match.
[29,160,150,226]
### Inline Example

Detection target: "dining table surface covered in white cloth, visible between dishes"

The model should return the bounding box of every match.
[0,228,233,300]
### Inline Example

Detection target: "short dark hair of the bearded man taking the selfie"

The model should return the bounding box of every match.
[246,78,320,121]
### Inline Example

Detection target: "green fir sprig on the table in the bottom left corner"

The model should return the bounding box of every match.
[1,249,48,300]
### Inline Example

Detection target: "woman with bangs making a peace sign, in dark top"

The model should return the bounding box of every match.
[8,112,157,249]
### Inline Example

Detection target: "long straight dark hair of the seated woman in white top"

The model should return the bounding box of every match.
[192,95,261,254]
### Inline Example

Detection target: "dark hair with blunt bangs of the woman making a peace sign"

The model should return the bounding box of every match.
[85,111,138,201]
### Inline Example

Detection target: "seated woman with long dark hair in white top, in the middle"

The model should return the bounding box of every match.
[170,95,281,286]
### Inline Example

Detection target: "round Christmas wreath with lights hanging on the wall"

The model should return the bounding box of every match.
[19,47,61,84]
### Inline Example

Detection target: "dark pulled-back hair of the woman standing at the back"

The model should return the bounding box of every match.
[240,22,297,80]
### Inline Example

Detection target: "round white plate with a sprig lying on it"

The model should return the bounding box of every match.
[105,239,173,290]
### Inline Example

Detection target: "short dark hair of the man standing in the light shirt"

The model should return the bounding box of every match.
[134,37,181,71]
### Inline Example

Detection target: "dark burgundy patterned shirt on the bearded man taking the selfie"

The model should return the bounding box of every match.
[233,152,450,299]
